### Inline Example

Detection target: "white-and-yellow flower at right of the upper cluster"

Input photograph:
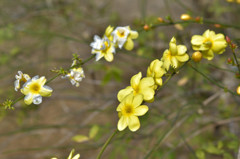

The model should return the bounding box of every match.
[112,26,138,50]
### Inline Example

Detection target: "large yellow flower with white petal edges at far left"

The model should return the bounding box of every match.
[21,76,53,105]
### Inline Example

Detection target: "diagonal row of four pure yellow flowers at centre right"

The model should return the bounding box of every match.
[117,37,189,131]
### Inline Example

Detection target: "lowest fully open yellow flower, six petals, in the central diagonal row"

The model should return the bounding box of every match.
[117,93,148,131]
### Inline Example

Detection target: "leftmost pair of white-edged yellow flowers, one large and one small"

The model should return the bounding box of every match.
[14,71,53,105]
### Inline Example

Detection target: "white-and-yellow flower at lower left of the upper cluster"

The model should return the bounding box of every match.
[90,35,115,62]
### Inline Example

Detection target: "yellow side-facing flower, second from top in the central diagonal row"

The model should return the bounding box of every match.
[147,59,166,89]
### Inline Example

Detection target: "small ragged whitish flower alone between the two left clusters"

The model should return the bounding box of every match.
[62,67,85,87]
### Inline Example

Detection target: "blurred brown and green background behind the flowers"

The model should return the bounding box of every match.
[0,0,240,159]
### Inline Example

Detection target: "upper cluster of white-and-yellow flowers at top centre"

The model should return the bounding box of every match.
[90,26,138,62]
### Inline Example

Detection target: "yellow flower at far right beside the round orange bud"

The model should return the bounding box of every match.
[191,30,227,60]
